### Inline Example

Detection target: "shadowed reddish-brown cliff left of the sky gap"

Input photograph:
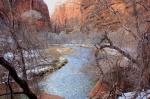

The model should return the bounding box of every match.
[0,0,51,30]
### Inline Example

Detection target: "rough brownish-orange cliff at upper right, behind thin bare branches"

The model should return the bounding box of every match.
[81,0,149,33]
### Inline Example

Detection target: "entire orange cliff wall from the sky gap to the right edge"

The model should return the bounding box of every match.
[52,0,150,33]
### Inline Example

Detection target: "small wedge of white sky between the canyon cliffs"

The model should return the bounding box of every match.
[44,0,66,14]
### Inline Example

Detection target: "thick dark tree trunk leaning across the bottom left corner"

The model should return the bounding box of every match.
[0,57,37,99]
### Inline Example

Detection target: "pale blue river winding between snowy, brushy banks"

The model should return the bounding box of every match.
[40,47,94,99]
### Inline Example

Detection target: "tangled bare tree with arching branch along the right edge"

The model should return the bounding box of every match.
[89,0,150,99]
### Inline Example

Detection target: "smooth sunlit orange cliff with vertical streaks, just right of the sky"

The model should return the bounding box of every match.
[51,0,81,33]
